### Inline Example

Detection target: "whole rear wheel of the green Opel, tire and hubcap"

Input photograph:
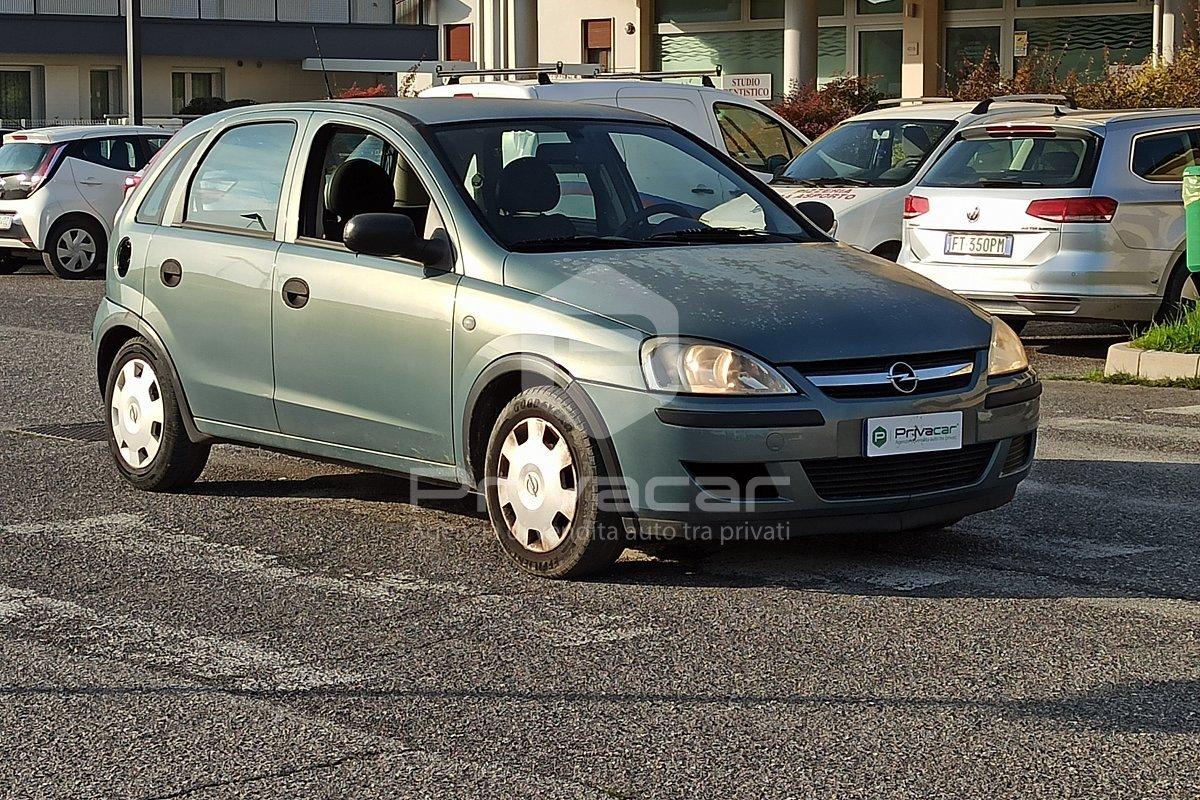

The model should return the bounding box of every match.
[104,337,210,492]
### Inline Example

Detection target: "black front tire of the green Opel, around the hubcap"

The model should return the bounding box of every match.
[484,386,625,578]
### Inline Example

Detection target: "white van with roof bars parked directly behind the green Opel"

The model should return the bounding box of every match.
[420,78,808,190]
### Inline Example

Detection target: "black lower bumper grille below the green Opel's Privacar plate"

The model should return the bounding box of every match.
[803,441,996,500]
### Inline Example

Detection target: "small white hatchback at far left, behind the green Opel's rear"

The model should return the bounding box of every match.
[0,125,170,278]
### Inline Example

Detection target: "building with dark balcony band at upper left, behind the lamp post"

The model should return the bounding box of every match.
[0,0,438,126]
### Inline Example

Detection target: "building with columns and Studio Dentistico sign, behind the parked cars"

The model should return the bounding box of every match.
[431,0,1198,97]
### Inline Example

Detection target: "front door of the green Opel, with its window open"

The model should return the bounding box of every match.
[271,120,460,464]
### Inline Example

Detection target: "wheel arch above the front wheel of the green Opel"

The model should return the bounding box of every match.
[462,353,620,486]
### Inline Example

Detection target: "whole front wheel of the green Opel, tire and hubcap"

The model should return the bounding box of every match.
[484,386,625,578]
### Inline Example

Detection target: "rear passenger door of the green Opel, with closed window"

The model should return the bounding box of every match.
[143,115,307,431]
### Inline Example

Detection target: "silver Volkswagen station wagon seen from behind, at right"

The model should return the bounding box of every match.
[900,109,1200,323]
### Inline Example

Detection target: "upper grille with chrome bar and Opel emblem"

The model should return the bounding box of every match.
[792,350,976,399]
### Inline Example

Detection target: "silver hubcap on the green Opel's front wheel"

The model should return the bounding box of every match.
[496,416,577,553]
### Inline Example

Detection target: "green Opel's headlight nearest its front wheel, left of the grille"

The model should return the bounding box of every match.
[642,338,796,395]
